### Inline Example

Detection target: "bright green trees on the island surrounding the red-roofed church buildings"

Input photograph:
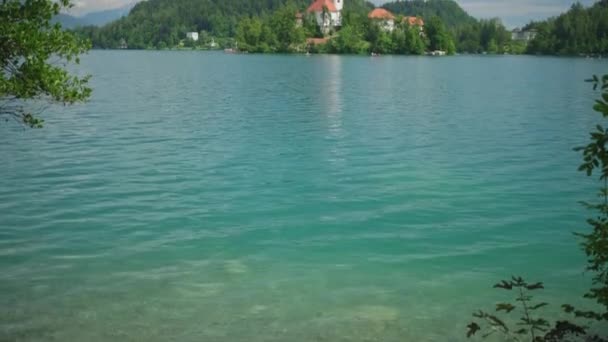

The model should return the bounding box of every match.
[236,6,456,55]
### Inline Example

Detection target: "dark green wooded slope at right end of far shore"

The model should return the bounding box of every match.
[525,0,608,55]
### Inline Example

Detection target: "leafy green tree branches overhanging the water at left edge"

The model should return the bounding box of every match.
[0,0,91,128]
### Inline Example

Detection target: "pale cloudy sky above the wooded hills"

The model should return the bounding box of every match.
[71,0,595,27]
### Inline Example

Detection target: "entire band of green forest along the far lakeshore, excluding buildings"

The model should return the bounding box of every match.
[78,0,608,54]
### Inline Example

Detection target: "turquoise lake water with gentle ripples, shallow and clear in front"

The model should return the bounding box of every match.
[0,51,608,342]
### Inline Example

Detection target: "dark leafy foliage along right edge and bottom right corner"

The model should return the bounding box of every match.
[467,75,608,342]
